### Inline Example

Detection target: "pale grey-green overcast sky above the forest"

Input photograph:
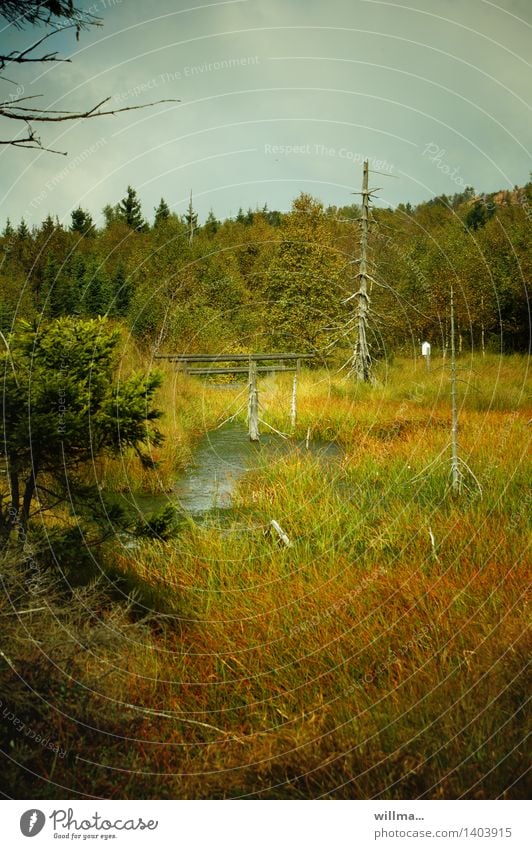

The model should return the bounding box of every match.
[0,0,532,225]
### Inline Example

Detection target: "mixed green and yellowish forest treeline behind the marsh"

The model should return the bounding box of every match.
[0,177,532,354]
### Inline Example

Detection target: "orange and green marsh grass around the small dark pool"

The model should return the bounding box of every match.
[2,350,530,799]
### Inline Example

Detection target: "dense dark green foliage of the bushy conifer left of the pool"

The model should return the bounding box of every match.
[0,318,162,537]
